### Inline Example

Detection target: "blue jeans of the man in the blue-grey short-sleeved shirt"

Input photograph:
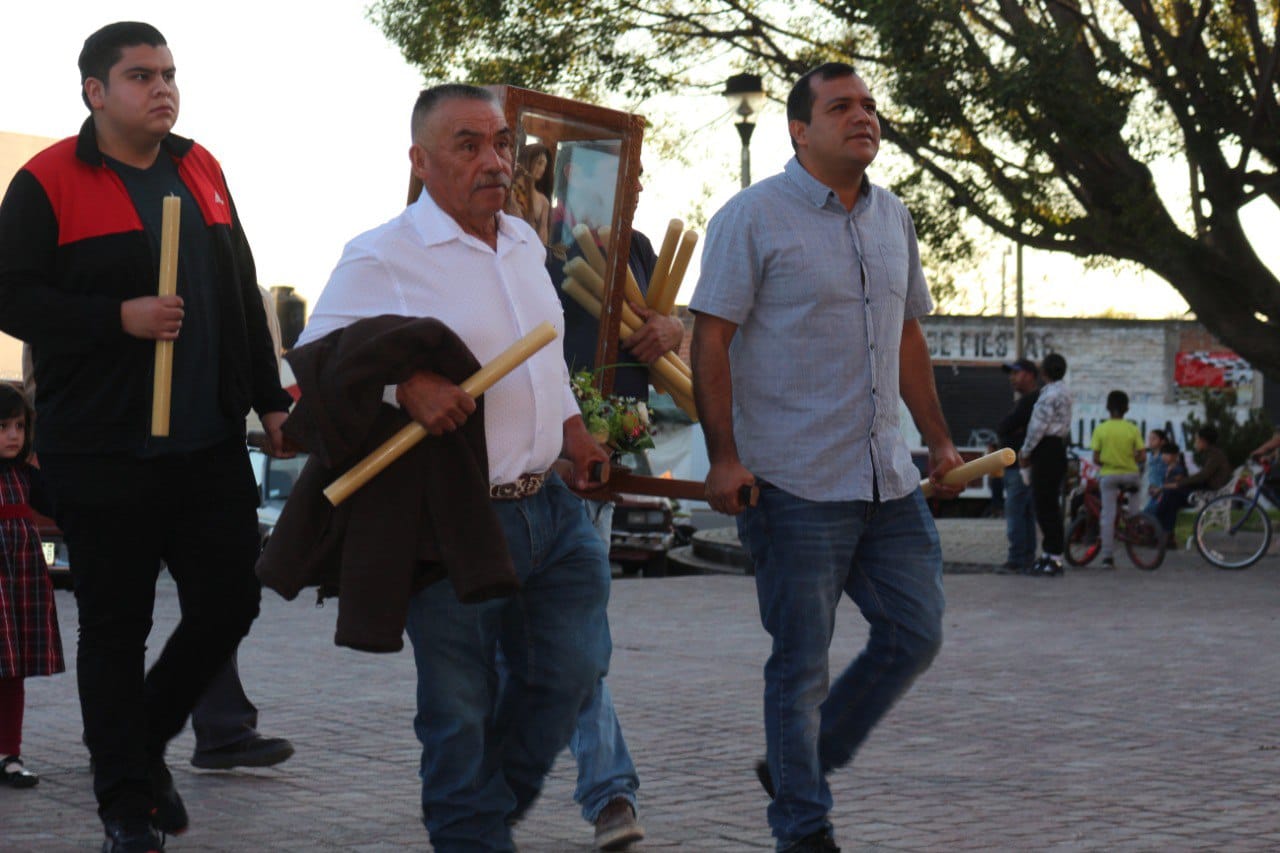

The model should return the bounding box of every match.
[737,485,943,850]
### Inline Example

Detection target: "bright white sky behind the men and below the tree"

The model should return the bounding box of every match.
[0,0,1280,316]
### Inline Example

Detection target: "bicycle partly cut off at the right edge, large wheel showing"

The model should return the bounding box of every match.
[1192,460,1280,569]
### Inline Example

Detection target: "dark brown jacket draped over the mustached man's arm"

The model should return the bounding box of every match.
[257,315,520,652]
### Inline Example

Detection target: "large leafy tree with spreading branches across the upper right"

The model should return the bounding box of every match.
[371,0,1280,377]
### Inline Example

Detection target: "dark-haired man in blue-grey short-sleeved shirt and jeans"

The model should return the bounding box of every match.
[690,63,960,853]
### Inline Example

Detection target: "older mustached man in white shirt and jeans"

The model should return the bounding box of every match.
[300,85,611,853]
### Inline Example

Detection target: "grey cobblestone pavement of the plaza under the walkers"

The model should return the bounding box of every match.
[0,521,1280,853]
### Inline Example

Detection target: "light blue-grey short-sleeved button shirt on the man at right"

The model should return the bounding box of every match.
[690,159,932,501]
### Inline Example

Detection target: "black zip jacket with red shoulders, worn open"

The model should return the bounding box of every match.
[0,118,291,453]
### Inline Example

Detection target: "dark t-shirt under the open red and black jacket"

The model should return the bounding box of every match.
[104,151,241,456]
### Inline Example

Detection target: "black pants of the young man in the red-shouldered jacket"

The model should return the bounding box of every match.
[41,441,260,818]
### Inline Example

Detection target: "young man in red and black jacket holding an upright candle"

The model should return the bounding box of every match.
[0,23,291,852]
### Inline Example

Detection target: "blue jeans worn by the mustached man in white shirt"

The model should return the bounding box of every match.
[407,475,611,853]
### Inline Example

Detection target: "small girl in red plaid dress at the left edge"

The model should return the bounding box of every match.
[0,383,65,788]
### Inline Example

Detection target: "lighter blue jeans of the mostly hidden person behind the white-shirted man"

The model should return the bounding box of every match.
[568,501,640,824]
